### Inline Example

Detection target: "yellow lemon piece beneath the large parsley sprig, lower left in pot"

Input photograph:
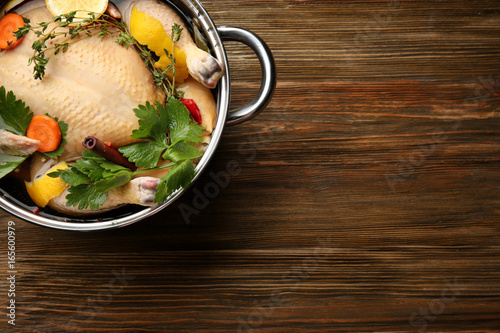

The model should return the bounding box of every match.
[25,162,69,208]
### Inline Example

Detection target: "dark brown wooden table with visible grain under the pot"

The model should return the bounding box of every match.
[0,0,500,332]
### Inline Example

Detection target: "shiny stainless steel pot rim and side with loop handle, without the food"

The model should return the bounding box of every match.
[0,0,276,231]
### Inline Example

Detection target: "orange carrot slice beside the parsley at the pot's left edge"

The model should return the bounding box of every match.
[26,115,61,153]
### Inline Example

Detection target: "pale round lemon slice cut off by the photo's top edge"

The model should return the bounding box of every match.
[45,0,108,21]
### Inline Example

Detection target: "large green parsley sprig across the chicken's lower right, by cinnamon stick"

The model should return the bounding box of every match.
[49,98,203,210]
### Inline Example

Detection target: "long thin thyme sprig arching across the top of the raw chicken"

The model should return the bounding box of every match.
[15,11,182,98]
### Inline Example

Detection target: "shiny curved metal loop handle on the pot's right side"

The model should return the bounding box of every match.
[217,26,276,125]
